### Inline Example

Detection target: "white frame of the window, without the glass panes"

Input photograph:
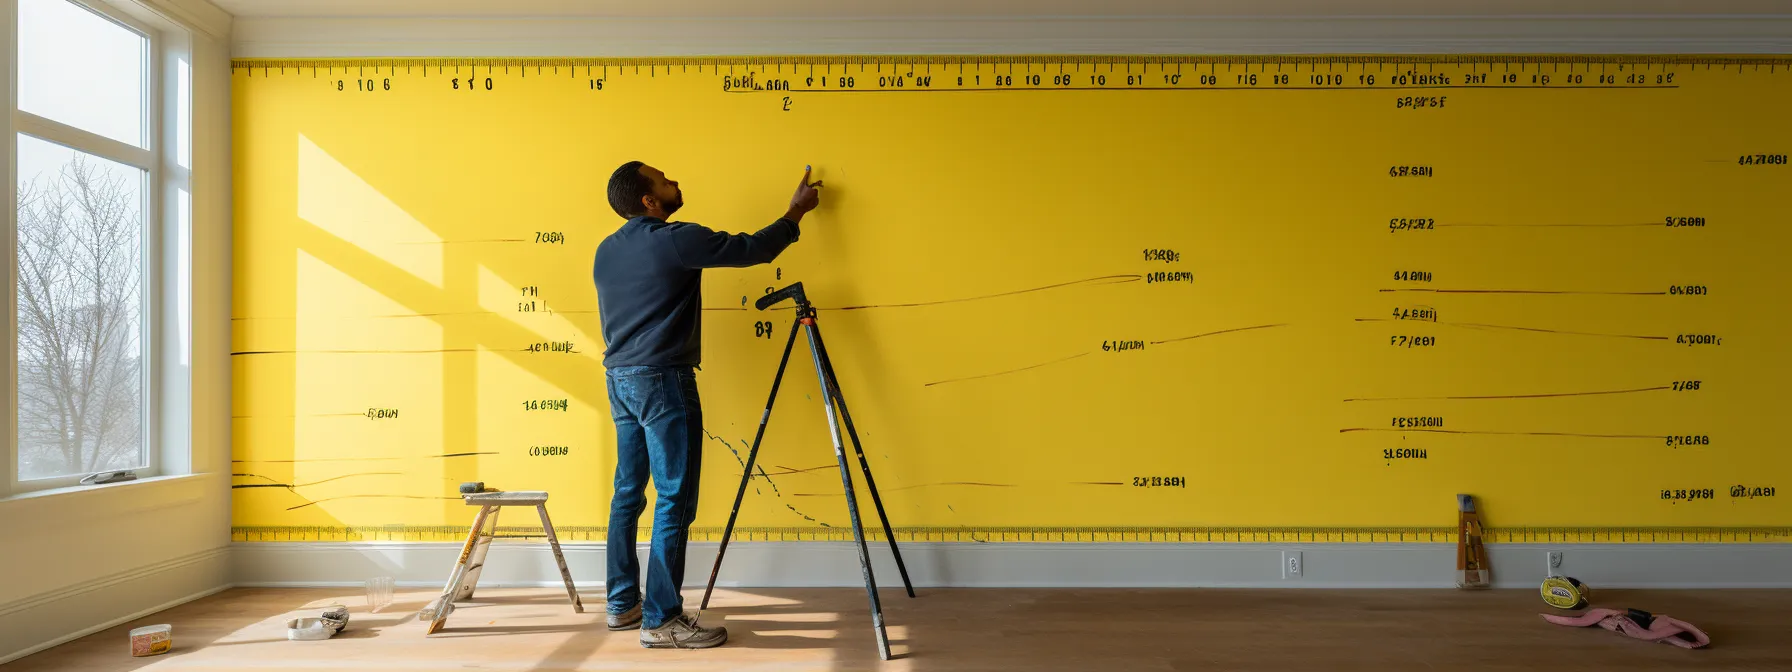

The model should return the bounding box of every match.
[0,0,194,500]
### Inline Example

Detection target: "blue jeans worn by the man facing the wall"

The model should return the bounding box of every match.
[604,366,702,627]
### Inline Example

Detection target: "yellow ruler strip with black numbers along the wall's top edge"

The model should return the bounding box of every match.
[231,54,1792,93]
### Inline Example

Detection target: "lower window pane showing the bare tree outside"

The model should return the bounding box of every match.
[18,136,145,478]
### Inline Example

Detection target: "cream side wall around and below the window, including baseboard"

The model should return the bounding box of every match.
[0,0,231,663]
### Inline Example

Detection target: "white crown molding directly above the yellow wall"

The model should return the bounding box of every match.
[233,16,1792,57]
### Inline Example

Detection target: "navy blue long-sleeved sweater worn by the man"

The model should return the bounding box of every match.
[591,217,799,369]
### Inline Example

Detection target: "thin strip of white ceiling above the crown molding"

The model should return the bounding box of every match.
[213,0,1792,18]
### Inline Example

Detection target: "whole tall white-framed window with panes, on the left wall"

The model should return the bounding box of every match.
[0,0,190,495]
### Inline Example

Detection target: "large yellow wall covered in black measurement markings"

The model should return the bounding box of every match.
[233,57,1792,541]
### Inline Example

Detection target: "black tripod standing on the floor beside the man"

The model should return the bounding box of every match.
[699,283,914,659]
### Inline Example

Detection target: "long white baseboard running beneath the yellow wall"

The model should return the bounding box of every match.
[235,541,1792,590]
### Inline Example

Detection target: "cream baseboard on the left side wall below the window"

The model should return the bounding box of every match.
[0,547,233,665]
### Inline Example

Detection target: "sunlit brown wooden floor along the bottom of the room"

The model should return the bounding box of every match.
[5,588,1792,672]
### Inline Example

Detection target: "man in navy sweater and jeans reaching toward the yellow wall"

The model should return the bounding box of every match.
[591,161,821,649]
